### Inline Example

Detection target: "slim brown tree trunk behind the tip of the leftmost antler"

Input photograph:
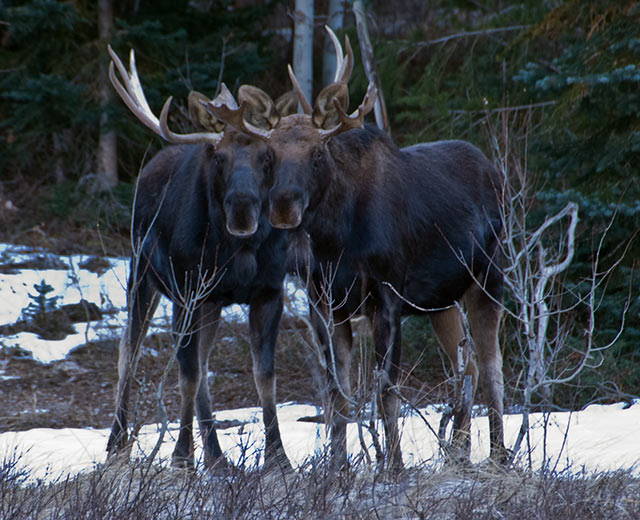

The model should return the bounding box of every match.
[95,0,118,190]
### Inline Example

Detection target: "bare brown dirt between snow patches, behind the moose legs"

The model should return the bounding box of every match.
[0,308,444,431]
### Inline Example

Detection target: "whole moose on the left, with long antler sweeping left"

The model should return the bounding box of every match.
[107,47,296,467]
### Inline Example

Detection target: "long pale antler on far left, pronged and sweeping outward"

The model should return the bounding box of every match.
[108,45,222,144]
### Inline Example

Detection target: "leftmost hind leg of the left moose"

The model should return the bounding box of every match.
[107,277,160,456]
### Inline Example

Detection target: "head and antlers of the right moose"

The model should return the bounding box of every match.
[190,27,376,229]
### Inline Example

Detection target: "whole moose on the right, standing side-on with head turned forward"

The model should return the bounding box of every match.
[212,30,508,468]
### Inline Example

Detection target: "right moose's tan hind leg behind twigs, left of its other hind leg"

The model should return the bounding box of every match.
[431,307,478,461]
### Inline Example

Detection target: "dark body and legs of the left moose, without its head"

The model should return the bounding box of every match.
[108,140,287,465]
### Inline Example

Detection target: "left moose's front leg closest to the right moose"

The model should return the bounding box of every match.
[249,288,290,467]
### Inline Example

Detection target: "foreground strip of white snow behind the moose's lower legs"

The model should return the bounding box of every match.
[0,402,640,480]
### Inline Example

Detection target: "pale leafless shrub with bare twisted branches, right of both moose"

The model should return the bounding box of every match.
[486,108,629,464]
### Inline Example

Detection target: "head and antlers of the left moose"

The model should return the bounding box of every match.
[109,47,286,237]
